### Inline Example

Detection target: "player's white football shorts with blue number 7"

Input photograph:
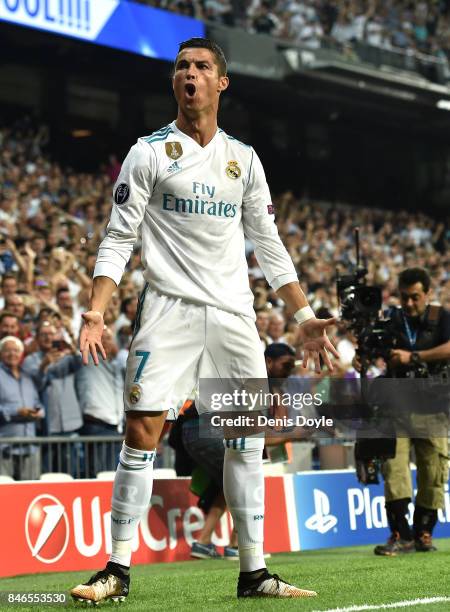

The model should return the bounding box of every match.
[124,286,267,419]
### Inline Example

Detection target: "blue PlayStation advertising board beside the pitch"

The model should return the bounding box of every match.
[294,470,450,550]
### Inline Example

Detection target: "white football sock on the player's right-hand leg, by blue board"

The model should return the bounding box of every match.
[223,437,266,572]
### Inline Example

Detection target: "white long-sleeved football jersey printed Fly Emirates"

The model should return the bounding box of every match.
[94,122,297,318]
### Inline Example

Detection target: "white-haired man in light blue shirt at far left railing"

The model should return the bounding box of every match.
[0,336,44,480]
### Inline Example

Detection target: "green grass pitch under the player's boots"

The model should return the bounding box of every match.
[0,540,450,612]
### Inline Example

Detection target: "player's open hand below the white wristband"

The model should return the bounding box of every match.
[299,317,339,373]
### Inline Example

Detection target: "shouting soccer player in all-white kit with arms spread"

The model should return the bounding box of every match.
[71,38,338,602]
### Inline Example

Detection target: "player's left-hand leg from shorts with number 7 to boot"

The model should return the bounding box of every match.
[71,290,204,602]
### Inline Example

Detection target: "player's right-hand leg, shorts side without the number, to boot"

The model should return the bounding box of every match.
[199,308,316,597]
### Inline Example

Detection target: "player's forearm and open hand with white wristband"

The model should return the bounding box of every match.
[277,282,339,372]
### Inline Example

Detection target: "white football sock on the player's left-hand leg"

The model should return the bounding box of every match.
[109,442,156,567]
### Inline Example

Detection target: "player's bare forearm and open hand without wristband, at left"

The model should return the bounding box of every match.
[80,276,117,365]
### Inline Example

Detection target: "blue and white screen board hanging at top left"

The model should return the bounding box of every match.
[0,0,205,61]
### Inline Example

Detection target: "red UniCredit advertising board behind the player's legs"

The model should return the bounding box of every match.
[0,477,289,576]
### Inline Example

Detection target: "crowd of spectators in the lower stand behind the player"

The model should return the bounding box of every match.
[0,118,450,477]
